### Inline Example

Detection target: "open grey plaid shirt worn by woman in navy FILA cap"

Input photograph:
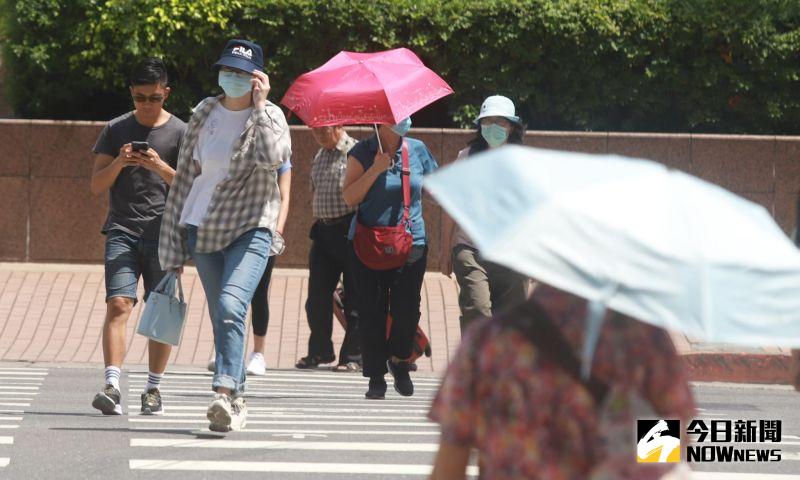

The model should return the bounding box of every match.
[158,96,292,270]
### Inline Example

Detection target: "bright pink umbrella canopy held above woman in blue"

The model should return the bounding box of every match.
[281,48,453,127]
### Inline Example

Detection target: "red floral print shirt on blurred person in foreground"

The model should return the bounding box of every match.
[429,285,695,480]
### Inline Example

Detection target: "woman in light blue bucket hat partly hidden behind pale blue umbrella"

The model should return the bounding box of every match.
[439,95,528,333]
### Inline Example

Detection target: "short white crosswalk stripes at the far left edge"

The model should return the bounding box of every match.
[0,366,48,472]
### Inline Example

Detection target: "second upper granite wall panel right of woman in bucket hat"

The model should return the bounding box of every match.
[608,133,692,172]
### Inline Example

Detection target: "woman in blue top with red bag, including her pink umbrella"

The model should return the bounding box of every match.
[281,48,453,399]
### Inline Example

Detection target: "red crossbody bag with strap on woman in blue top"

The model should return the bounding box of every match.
[353,139,414,270]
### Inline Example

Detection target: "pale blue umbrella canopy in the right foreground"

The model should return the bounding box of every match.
[425,146,800,346]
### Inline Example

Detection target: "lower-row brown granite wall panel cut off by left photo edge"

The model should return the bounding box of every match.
[0,177,30,262]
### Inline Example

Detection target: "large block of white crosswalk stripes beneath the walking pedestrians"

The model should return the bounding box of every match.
[128,370,477,479]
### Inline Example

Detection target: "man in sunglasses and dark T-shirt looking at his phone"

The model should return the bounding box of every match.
[91,58,186,415]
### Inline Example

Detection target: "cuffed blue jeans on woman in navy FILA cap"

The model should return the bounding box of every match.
[187,225,272,393]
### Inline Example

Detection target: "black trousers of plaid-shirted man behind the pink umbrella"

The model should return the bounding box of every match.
[306,215,361,363]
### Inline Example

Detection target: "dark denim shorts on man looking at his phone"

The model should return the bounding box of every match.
[105,230,166,305]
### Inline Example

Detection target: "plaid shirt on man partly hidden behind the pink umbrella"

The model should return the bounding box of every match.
[311,133,356,218]
